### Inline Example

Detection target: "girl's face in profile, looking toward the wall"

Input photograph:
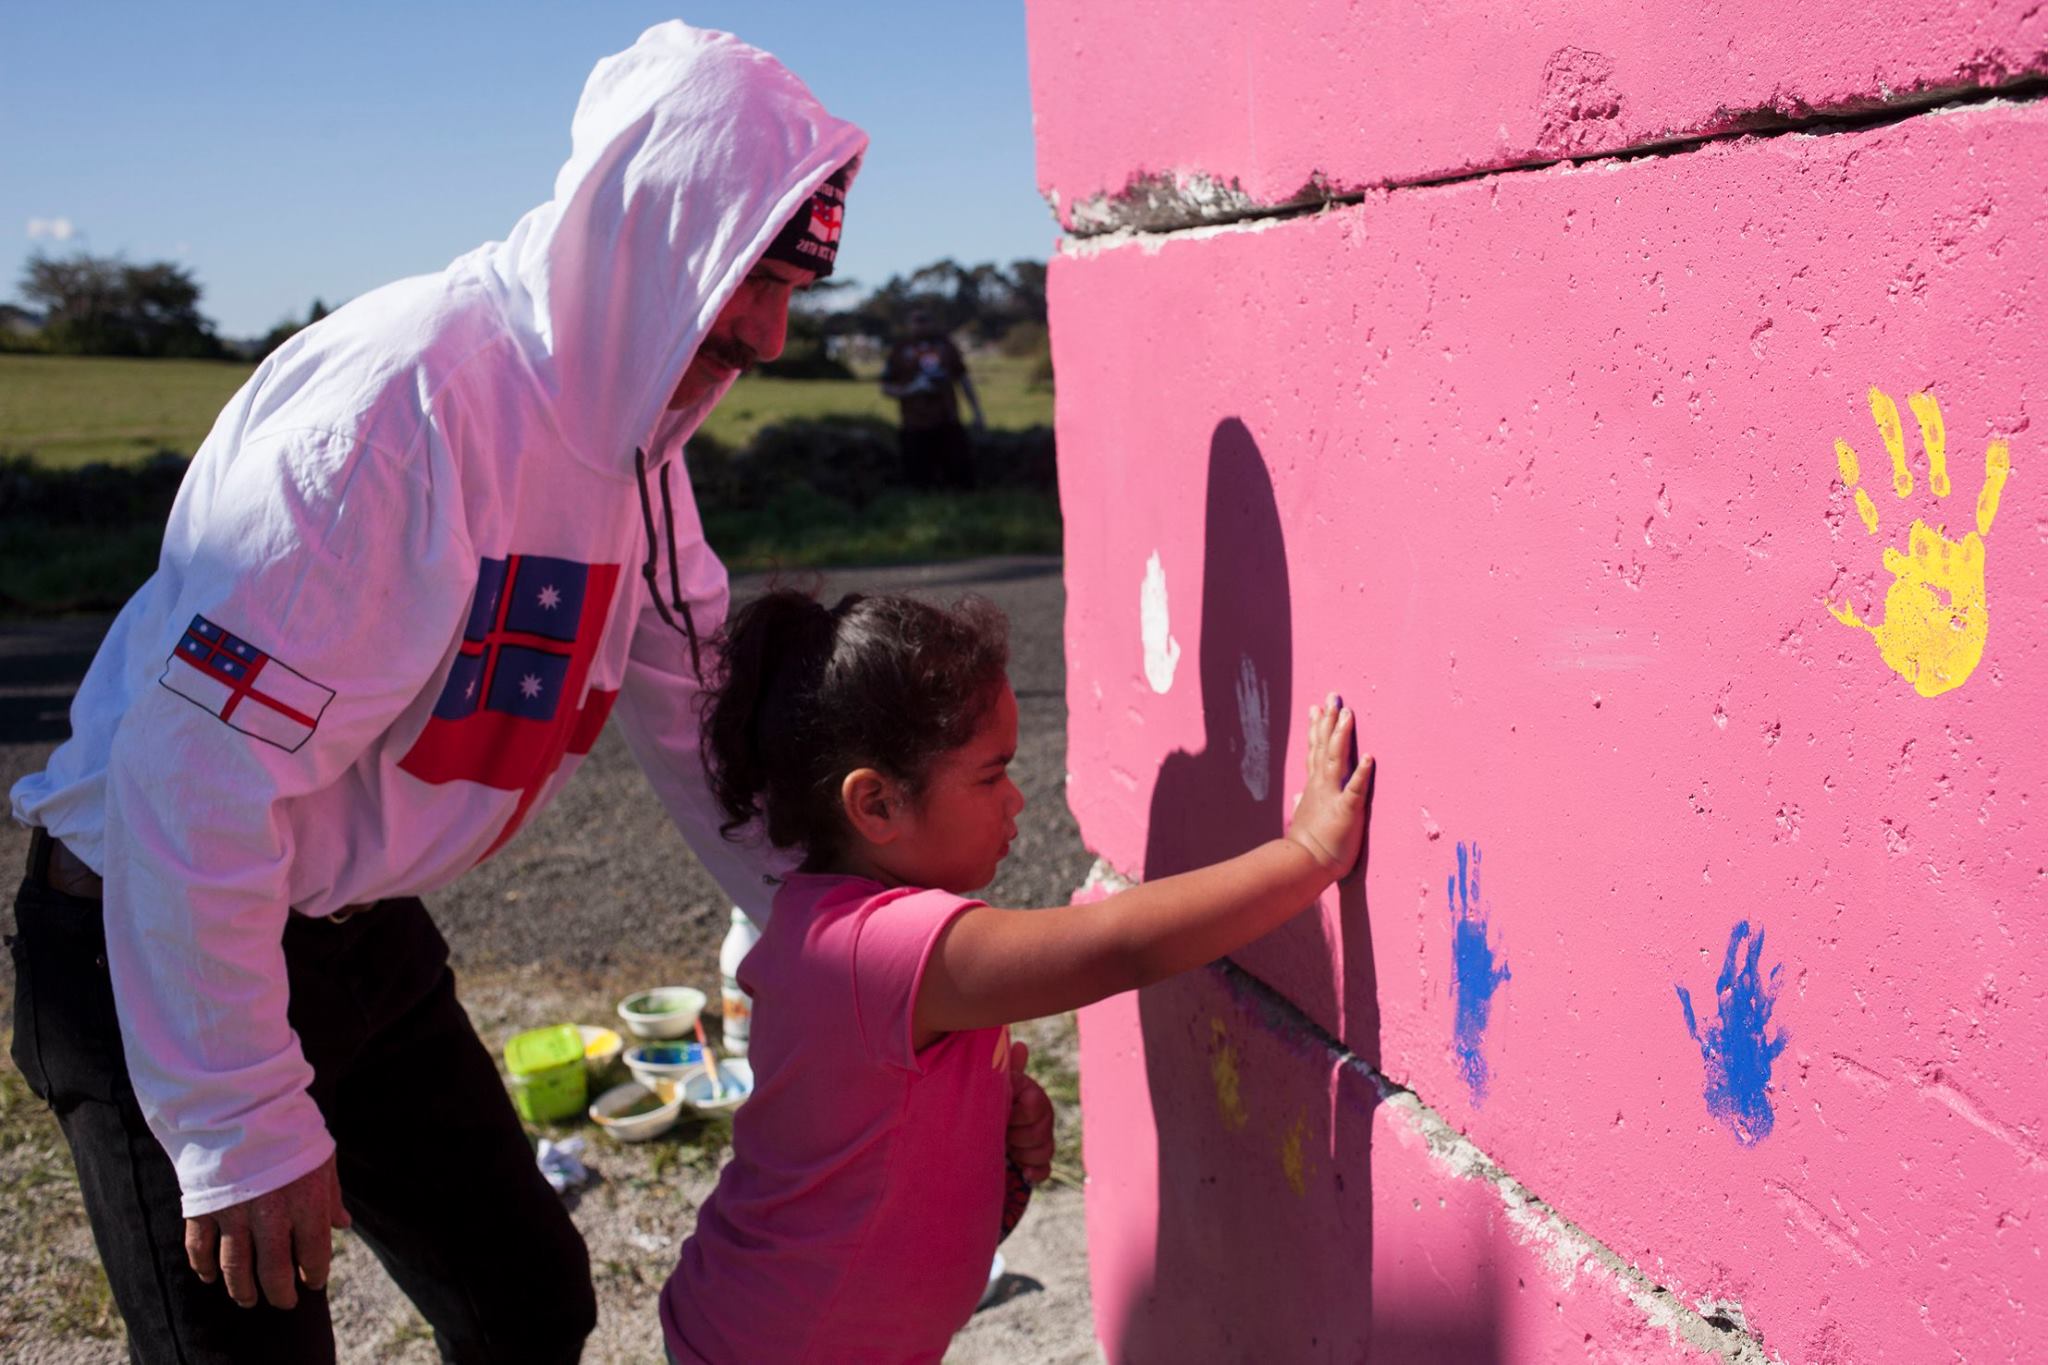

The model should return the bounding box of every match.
[877,681,1024,896]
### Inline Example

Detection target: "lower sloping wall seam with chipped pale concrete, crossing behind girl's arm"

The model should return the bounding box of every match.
[1075,855,1784,1365]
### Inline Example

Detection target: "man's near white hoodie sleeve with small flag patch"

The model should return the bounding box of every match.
[102,430,475,1218]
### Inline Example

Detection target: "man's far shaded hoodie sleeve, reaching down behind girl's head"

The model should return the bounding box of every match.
[616,462,793,925]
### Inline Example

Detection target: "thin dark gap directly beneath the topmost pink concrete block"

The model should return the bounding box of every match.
[1065,76,2048,250]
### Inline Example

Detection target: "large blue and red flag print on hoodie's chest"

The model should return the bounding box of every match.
[399,555,618,855]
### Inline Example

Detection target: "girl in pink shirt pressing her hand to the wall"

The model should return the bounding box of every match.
[662,589,1372,1365]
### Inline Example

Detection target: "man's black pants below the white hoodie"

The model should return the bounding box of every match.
[10,882,598,1365]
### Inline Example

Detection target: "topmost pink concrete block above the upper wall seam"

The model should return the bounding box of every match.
[1030,0,2048,233]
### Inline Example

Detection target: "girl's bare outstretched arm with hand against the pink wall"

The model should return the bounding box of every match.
[915,696,1372,1048]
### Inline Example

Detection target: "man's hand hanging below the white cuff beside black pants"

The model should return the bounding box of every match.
[184,1156,352,1308]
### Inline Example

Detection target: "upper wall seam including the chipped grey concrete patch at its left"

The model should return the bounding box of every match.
[1047,76,2048,256]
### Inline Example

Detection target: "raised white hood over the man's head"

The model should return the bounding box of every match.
[453,20,868,479]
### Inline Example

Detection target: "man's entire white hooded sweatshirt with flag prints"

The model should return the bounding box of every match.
[12,23,866,1216]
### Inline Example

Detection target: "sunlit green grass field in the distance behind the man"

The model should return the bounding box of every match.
[0,356,1053,469]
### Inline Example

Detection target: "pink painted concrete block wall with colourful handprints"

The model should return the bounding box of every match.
[1032,0,2048,1361]
